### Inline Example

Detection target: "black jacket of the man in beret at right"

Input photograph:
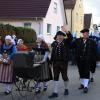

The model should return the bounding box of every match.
[72,38,97,61]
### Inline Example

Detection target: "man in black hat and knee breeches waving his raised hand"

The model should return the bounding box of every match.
[49,31,72,98]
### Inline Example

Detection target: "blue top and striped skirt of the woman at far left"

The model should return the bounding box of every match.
[0,44,16,83]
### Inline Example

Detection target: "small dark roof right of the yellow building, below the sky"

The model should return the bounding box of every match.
[84,14,92,29]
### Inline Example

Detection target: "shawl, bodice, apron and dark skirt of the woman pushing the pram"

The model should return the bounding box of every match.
[33,42,52,82]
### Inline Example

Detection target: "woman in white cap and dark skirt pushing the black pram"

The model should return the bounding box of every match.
[33,35,52,93]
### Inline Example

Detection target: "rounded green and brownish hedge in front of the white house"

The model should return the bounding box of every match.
[0,24,36,43]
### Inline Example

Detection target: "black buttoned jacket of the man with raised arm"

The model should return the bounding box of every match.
[51,34,72,62]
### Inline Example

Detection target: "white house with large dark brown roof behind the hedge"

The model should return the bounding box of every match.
[0,0,66,43]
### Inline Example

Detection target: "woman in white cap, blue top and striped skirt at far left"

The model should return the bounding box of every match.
[0,35,16,95]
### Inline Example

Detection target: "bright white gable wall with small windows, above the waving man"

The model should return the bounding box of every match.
[43,0,66,41]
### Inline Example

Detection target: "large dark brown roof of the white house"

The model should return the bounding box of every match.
[0,0,51,18]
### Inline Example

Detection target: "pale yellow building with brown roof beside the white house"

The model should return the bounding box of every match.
[64,0,84,37]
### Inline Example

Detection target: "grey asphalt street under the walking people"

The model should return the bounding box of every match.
[0,66,100,100]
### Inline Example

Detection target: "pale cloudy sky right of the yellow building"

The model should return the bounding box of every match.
[83,0,100,24]
